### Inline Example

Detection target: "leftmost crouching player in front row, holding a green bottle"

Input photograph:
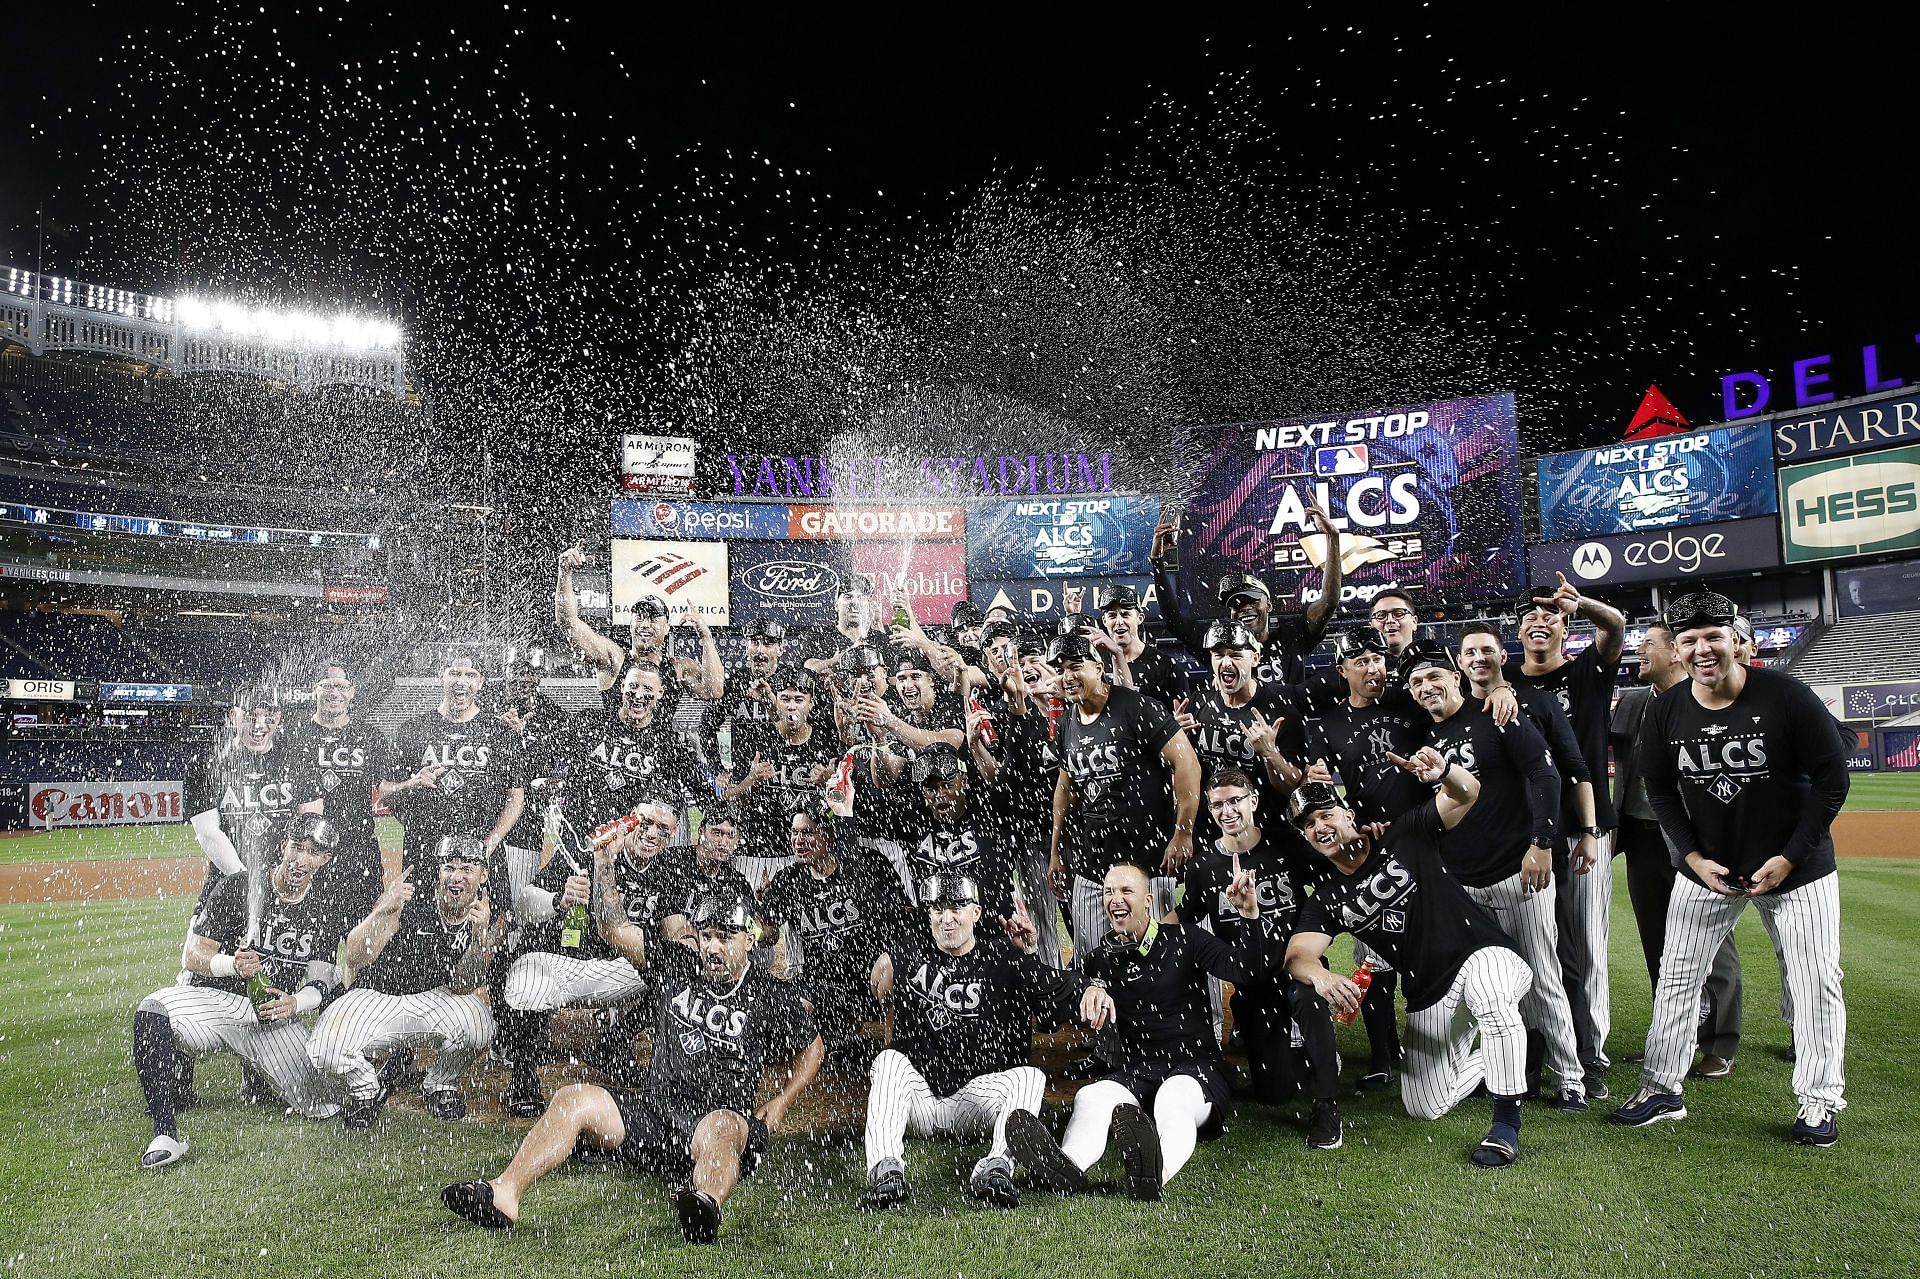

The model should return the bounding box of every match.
[132,812,348,1168]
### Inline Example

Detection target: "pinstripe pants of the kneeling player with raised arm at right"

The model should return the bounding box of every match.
[1400,947,1534,1120]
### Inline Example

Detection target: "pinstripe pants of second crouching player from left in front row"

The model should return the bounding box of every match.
[307,985,493,1100]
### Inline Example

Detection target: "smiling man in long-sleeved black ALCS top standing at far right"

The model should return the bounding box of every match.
[1611,591,1847,1146]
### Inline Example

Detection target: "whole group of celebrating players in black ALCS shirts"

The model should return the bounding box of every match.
[132,513,1847,1241]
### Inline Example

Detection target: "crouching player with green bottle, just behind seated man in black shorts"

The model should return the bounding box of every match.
[493,791,687,1120]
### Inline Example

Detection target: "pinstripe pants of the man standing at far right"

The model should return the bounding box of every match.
[1642,874,1847,1110]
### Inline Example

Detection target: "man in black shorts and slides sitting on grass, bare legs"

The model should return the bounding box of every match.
[440,833,826,1243]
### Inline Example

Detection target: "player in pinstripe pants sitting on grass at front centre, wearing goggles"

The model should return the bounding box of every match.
[860,870,1114,1208]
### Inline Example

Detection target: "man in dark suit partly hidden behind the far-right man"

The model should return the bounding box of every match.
[1611,622,1741,1079]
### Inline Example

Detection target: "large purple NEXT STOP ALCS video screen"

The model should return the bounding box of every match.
[1177,392,1526,611]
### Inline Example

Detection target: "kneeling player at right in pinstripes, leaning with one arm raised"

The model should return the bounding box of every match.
[1286,768,1534,1168]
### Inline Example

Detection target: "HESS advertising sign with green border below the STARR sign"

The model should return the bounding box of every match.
[1780,444,1920,565]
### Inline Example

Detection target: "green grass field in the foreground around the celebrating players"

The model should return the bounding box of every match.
[0,860,1920,1279]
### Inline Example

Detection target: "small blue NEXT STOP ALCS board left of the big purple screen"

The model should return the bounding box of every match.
[966,497,1162,580]
